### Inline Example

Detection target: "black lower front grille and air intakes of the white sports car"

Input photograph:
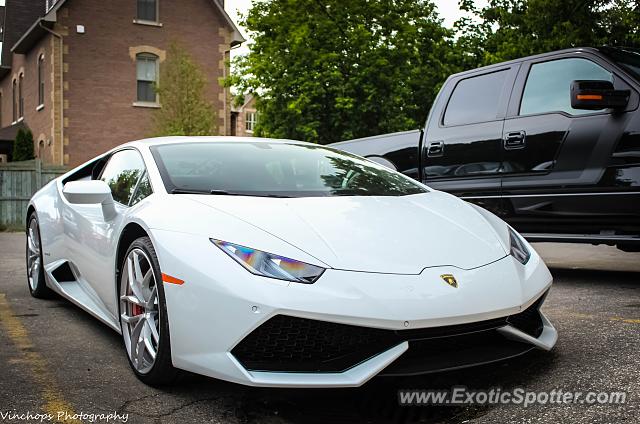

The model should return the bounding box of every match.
[231,296,544,372]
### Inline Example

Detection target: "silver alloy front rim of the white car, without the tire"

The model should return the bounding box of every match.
[120,248,160,374]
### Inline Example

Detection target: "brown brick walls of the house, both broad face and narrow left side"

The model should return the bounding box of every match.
[0,0,231,166]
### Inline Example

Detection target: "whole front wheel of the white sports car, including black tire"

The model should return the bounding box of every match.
[118,237,178,386]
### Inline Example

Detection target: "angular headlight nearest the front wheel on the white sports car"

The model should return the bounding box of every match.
[210,239,324,284]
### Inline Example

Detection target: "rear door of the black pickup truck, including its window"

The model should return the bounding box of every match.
[422,63,519,212]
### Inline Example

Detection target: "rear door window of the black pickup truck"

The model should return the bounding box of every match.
[443,70,508,126]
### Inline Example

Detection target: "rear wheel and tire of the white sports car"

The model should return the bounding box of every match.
[25,212,54,299]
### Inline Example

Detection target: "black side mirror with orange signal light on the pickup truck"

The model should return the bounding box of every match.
[571,80,631,110]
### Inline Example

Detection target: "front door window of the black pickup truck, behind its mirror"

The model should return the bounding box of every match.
[520,58,613,115]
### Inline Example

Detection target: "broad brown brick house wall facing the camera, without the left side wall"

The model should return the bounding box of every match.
[58,0,230,165]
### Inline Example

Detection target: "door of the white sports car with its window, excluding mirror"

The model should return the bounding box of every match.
[64,148,151,319]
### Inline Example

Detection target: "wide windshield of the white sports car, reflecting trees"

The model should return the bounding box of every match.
[151,141,427,197]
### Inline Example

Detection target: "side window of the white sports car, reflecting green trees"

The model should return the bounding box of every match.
[100,149,145,205]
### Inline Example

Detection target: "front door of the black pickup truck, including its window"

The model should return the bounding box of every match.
[502,52,636,239]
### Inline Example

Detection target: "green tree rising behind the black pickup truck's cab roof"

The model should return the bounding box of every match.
[457,0,640,67]
